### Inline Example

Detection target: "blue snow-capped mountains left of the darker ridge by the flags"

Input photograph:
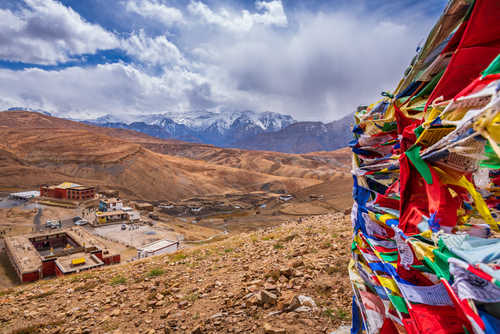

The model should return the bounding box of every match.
[80,111,296,147]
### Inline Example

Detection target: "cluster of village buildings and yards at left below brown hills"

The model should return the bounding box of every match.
[3,182,189,283]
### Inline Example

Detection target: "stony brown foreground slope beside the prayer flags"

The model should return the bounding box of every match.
[0,215,351,333]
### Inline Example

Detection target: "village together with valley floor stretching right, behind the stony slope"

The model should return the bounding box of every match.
[0,182,352,285]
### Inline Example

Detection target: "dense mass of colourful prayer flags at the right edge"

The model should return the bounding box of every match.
[349,0,500,334]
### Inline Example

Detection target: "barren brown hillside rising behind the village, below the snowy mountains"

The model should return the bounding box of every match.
[0,111,350,200]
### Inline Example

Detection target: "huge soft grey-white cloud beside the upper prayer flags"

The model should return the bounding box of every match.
[188,7,430,121]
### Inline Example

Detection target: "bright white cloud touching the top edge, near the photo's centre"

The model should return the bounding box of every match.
[188,0,288,32]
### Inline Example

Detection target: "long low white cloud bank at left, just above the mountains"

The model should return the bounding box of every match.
[0,63,204,117]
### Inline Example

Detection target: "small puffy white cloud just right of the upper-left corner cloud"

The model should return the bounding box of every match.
[121,30,186,66]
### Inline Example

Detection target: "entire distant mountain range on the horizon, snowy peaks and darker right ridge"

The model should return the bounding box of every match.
[5,107,352,153]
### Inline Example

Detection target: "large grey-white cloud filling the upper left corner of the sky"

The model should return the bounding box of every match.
[0,0,119,65]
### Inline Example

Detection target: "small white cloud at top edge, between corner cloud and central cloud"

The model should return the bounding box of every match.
[125,0,183,26]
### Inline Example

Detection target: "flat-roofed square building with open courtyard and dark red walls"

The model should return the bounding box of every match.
[5,227,120,282]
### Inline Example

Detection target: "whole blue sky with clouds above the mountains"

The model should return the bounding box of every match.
[0,0,446,122]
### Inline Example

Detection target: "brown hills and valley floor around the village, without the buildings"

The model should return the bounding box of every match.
[0,111,352,294]
